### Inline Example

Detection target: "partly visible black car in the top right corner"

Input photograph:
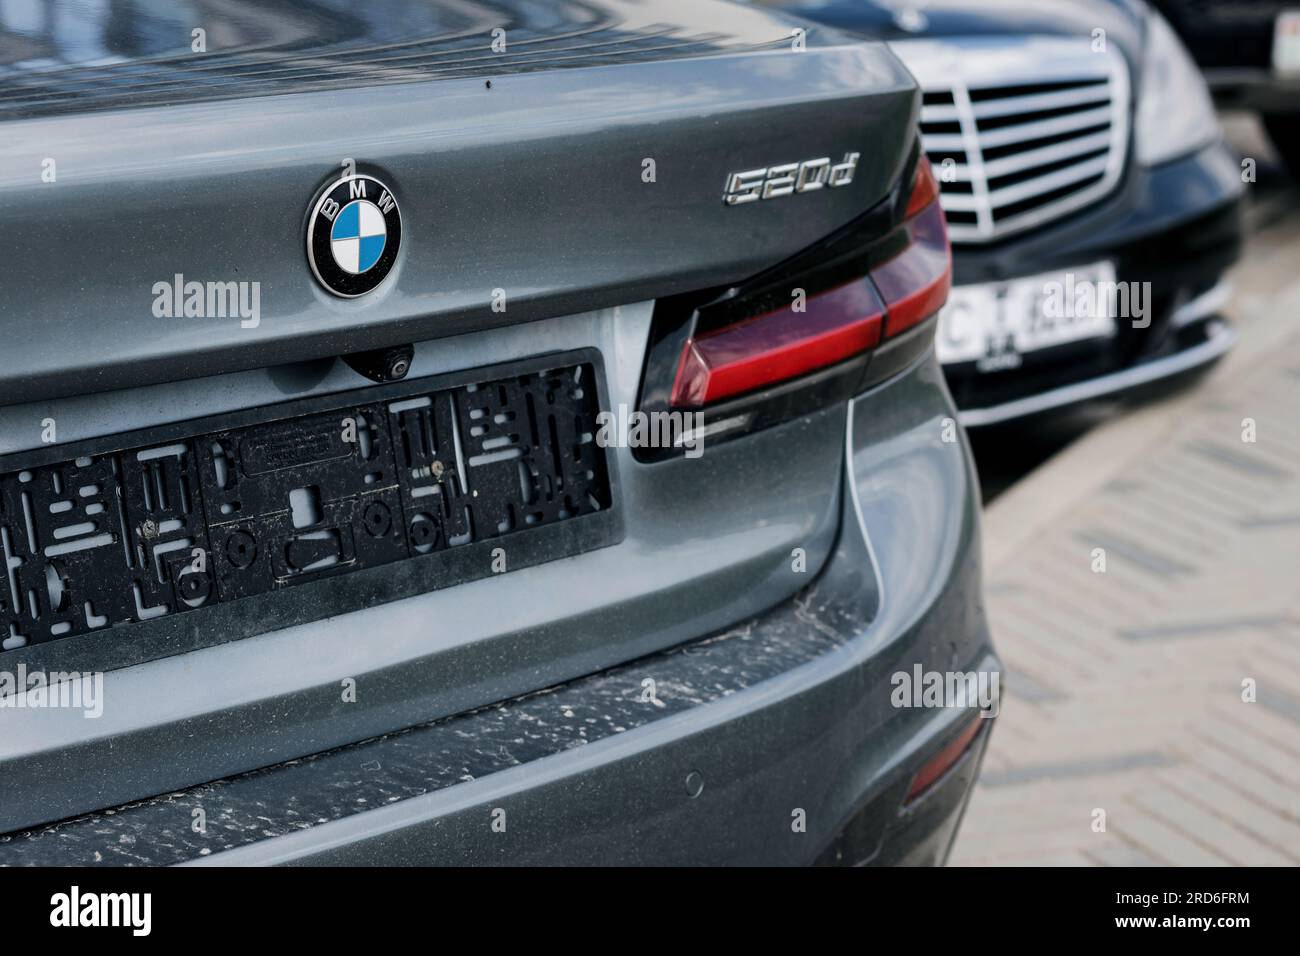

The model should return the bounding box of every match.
[1154,0,1300,178]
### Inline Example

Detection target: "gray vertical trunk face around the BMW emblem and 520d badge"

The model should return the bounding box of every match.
[0,36,917,403]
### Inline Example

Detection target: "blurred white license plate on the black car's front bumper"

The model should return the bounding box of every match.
[935,261,1115,372]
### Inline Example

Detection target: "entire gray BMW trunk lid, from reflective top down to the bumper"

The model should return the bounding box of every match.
[0,0,918,832]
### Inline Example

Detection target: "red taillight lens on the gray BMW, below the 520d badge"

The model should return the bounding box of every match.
[670,157,952,407]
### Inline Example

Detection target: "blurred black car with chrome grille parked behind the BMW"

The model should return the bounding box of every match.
[764,0,1244,425]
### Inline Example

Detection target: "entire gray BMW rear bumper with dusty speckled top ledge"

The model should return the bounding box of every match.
[0,356,998,865]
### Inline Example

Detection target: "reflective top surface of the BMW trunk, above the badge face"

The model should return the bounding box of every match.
[0,0,842,118]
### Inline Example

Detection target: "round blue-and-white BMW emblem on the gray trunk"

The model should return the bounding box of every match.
[307,174,402,298]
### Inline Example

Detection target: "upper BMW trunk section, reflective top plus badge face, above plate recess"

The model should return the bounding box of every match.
[0,0,915,408]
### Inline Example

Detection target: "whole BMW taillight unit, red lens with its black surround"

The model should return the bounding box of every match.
[638,150,952,458]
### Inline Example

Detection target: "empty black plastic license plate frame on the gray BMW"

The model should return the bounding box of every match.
[0,349,624,671]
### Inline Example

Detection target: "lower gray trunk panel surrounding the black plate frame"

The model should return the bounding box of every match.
[0,304,845,831]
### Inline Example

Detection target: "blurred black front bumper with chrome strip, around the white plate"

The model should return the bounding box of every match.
[944,142,1244,427]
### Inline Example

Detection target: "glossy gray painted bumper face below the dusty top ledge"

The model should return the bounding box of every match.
[215,358,998,865]
